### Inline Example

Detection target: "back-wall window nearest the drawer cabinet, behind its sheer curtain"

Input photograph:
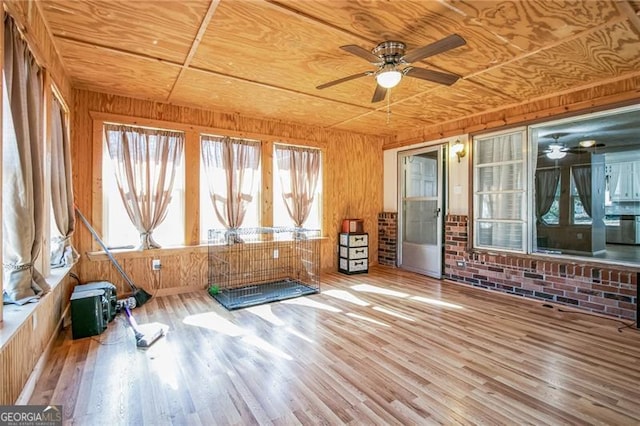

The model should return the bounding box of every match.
[273,145,322,229]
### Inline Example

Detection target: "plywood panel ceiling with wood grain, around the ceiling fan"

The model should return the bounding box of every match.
[39,0,640,135]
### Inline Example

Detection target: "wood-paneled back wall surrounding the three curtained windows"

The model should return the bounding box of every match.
[72,90,388,292]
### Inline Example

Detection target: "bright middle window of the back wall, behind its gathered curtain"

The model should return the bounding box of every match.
[200,135,262,244]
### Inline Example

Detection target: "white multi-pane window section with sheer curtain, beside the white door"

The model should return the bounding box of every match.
[473,129,527,252]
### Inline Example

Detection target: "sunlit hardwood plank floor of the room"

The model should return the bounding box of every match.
[30,267,640,425]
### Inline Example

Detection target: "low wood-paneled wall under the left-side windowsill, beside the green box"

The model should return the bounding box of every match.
[0,275,76,405]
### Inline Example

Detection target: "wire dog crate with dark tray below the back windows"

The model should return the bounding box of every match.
[208,228,320,310]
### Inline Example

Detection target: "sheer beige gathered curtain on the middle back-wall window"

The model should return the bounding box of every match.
[201,135,260,229]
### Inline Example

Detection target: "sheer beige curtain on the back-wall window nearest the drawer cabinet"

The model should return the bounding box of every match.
[275,145,320,228]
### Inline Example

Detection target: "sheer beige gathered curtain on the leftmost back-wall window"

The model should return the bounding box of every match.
[104,124,184,250]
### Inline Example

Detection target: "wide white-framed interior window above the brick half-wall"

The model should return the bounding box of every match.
[473,105,640,263]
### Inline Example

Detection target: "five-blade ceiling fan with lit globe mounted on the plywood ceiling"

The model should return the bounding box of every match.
[317,34,467,102]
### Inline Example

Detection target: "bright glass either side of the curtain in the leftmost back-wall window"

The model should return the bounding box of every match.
[102,125,185,249]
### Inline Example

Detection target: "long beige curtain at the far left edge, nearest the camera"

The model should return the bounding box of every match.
[2,16,50,304]
